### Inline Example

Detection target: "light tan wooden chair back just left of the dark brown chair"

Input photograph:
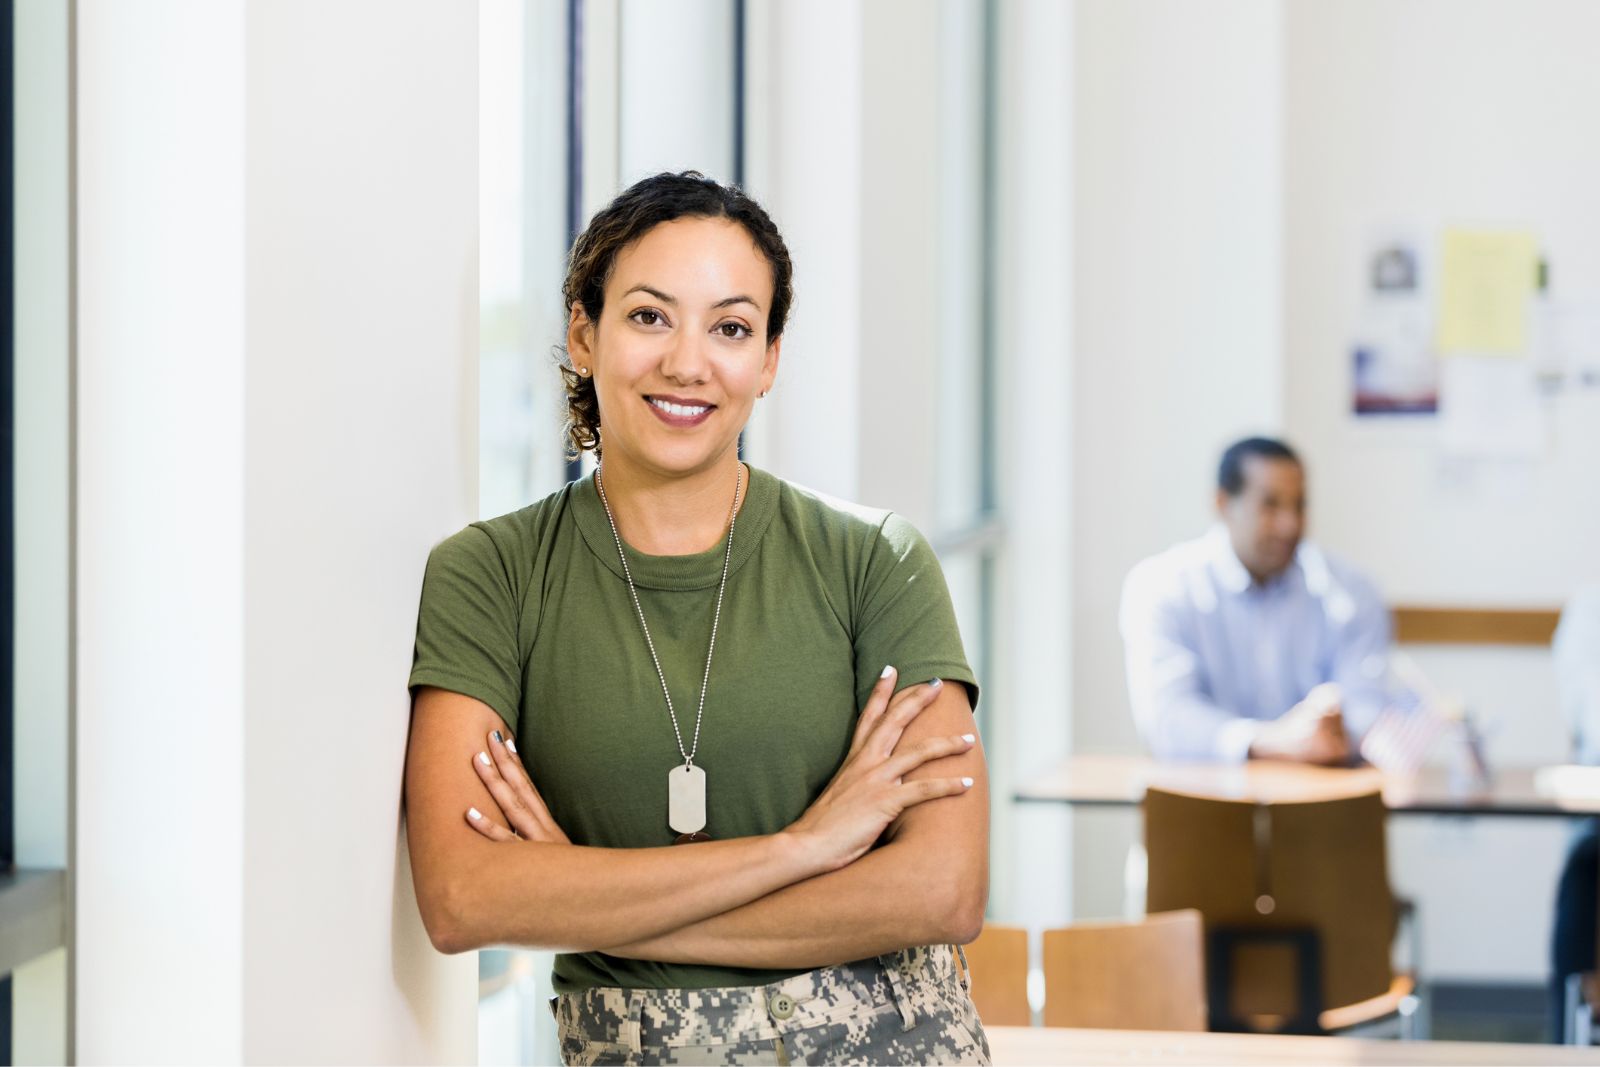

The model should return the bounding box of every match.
[1045,909,1206,1030]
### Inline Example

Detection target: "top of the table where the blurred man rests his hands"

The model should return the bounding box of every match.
[1016,755,1600,817]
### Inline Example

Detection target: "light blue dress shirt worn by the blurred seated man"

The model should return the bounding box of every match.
[1122,525,1390,763]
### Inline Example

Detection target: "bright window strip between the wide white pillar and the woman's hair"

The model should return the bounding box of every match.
[478,0,581,1064]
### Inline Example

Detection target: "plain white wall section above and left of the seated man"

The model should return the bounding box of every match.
[1070,0,1285,917]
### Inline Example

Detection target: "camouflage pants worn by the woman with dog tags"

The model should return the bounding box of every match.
[552,945,989,1064]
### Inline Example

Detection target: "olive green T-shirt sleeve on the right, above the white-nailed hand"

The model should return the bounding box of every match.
[854,514,978,709]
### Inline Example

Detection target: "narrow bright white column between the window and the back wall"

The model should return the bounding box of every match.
[990,0,1078,928]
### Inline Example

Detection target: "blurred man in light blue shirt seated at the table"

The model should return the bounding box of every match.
[1122,437,1389,765]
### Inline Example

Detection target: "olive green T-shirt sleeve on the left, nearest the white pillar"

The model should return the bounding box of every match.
[410,526,522,733]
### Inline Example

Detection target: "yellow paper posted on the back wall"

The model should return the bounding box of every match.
[1437,230,1539,355]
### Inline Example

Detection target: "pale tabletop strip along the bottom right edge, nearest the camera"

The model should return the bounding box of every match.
[986,1027,1600,1067]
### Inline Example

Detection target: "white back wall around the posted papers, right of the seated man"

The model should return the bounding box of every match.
[1285,0,1600,981]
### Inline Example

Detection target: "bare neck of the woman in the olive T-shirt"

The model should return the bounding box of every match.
[598,454,750,555]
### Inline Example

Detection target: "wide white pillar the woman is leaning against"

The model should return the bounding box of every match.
[74,0,477,1062]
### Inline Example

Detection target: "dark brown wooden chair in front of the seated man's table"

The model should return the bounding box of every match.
[1144,789,1416,1033]
